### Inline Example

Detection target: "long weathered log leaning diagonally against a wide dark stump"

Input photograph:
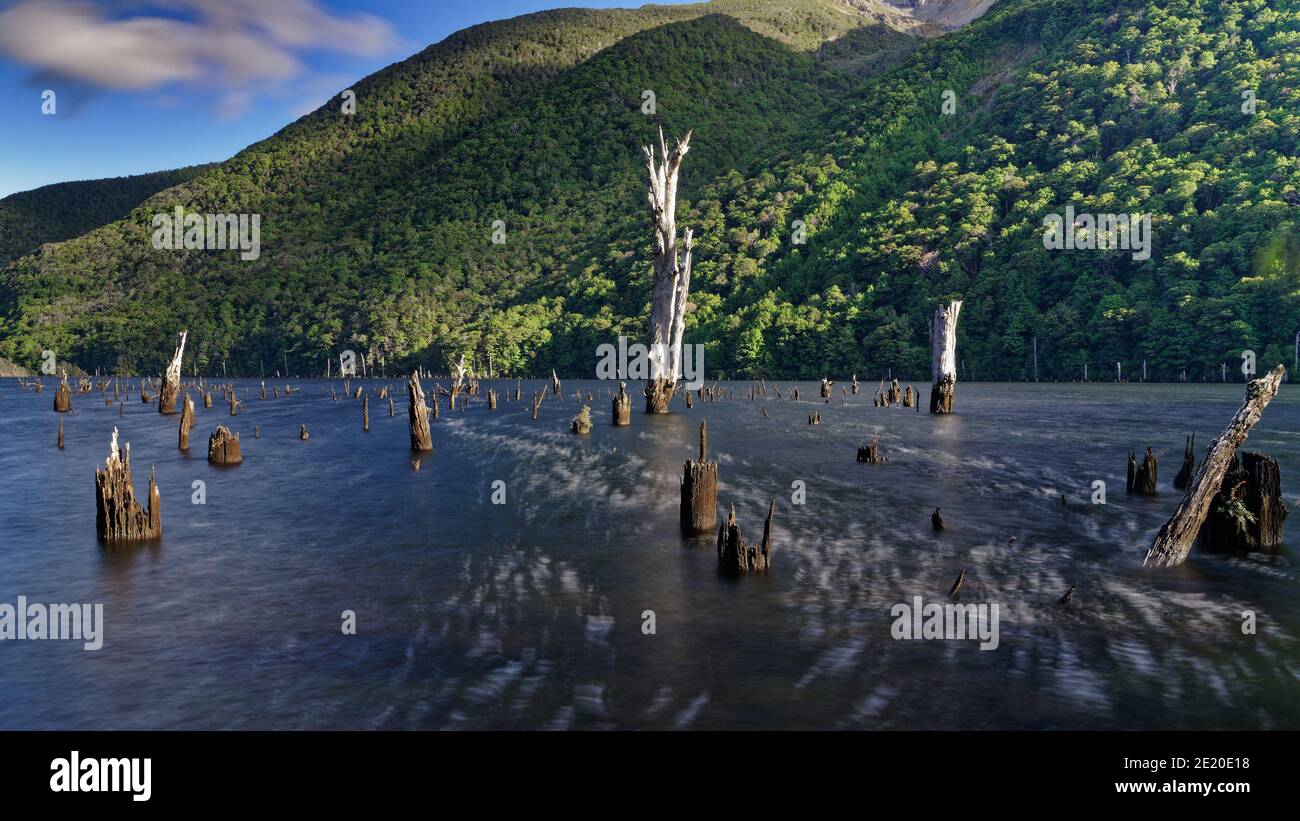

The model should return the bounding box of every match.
[1143,365,1286,568]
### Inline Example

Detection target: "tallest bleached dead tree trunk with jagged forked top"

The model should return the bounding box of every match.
[642,130,694,413]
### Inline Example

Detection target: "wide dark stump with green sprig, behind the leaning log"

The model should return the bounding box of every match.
[1196,451,1287,553]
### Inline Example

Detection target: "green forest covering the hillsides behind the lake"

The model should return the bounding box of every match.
[0,0,1300,381]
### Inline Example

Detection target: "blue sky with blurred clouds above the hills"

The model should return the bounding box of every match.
[0,0,702,197]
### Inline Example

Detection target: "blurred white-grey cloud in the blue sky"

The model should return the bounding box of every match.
[0,0,397,116]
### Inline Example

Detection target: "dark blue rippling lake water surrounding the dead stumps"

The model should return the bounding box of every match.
[0,379,1300,729]
